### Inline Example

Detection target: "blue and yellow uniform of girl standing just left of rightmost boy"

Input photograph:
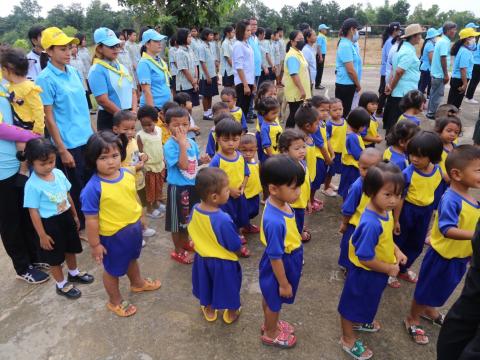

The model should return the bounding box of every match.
[395,165,442,273]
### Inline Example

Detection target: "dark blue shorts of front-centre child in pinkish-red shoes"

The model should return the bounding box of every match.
[259,246,303,312]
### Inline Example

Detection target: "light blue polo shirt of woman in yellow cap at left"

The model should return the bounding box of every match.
[35,62,93,149]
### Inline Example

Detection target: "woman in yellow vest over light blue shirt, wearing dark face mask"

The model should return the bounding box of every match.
[283,30,312,128]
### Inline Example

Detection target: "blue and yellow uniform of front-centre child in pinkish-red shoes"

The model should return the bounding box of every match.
[259,201,303,312]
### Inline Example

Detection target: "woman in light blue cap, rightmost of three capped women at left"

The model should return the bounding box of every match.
[137,29,172,109]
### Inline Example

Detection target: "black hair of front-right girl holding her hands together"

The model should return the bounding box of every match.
[363,162,405,198]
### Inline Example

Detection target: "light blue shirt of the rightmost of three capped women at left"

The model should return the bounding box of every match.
[137,59,172,108]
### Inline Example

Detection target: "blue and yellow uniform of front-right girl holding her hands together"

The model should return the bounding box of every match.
[338,209,397,324]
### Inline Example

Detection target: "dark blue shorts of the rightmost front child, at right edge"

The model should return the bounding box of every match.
[413,248,470,307]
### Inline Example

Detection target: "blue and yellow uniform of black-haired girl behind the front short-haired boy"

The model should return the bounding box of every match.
[210,151,250,229]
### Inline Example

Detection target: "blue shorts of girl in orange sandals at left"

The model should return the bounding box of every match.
[100,220,143,277]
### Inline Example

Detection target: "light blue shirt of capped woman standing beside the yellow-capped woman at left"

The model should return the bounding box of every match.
[88,62,133,110]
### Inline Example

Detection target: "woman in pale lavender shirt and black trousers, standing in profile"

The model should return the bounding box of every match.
[232,20,255,116]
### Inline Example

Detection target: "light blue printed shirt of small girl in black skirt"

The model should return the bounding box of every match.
[23,169,72,219]
